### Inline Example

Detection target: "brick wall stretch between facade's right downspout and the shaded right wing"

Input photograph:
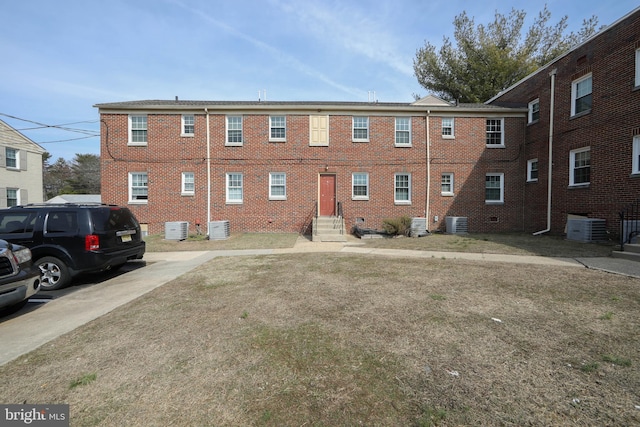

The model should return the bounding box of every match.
[429,117,526,232]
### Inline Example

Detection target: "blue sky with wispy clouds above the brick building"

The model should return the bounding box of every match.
[0,0,638,161]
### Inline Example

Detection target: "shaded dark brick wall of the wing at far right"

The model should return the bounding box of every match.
[491,6,640,237]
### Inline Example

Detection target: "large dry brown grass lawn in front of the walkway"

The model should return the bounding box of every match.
[0,238,640,426]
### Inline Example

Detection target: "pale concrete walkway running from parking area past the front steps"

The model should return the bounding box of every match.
[0,237,640,365]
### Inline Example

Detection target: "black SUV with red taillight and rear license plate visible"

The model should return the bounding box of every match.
[0,203,145,290]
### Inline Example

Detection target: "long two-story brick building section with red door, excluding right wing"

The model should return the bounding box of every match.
[97,97,527,234]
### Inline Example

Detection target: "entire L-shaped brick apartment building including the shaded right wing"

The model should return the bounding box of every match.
[96,8,640,241]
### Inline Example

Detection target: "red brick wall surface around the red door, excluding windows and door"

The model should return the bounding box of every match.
[99,101,525,234]
